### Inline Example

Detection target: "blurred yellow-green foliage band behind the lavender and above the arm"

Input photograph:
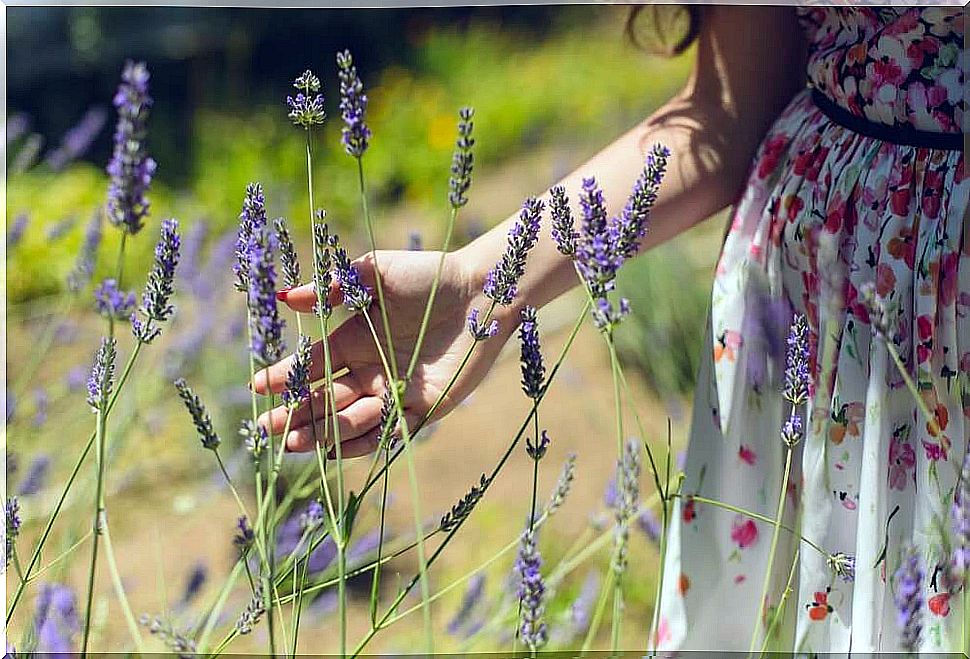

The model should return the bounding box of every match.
[7,8,687,301]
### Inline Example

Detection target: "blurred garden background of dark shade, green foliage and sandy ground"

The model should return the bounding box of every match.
[6,5,723,653]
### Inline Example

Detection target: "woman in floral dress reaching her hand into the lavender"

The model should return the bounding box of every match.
[256,7,970,652]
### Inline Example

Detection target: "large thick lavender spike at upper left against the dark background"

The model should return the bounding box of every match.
[106,61,156,234]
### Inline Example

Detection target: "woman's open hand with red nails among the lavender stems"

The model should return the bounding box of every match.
[253,251,517,457]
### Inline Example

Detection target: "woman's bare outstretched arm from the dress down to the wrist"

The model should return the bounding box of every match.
[455,6,805,313]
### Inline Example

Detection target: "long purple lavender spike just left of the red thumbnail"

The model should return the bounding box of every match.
[246,226,285,366]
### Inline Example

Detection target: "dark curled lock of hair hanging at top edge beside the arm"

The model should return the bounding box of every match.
[625,4,702,57]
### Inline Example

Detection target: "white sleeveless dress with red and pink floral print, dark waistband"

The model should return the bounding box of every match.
[655,7,970,653]
